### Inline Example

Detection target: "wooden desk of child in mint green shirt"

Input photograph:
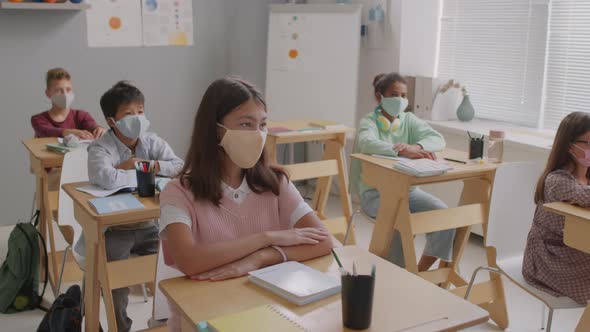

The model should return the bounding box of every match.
[352,150,508,328]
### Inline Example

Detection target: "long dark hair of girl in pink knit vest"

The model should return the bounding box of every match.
[180,77,286,206]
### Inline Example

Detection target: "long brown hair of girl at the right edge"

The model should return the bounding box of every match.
[535,112,590,204]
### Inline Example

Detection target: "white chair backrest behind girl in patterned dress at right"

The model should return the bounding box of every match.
[486,162,543,261]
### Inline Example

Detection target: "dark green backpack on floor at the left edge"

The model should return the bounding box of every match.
[0,210,49,313]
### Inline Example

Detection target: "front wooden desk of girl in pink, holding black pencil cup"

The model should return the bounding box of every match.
[160,246,488,332]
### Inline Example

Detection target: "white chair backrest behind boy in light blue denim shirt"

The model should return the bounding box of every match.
[57,148,88,245]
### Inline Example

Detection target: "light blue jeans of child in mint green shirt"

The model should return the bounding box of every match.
[361,188,455,267]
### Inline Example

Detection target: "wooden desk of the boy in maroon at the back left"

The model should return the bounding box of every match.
[23,137,81,296]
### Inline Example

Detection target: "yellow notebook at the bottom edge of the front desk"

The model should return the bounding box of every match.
[199,304,309,332]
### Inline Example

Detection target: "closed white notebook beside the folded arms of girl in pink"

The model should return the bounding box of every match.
[248,262,340,305]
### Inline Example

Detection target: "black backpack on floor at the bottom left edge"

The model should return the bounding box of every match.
[37,285,82,332]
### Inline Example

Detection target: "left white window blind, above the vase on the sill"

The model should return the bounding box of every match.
[438,0,552,126]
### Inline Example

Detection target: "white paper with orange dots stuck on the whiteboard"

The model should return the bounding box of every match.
[268,14,306,71]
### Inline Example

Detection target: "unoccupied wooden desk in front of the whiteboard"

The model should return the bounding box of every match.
[266,120,355,243]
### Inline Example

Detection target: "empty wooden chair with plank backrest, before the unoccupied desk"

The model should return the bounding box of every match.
[282,159,356,245]
